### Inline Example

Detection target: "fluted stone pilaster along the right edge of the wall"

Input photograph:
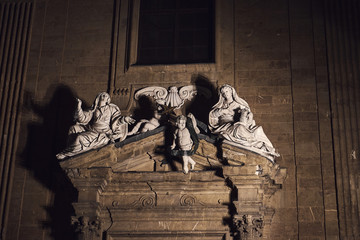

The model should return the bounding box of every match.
[325,0,359,239]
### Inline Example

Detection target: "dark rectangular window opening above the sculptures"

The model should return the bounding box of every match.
[137,0,215,65]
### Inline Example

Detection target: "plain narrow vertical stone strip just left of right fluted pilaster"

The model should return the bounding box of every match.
[313,1,340,236]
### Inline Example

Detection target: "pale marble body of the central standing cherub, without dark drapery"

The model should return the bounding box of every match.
[171,115,196,174]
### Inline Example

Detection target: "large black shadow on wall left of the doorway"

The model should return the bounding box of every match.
[22,85,77,240]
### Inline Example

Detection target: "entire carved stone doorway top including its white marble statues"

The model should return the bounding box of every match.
[57,84,286,240]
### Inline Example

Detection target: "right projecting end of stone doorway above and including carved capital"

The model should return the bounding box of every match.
[223,142,286,240]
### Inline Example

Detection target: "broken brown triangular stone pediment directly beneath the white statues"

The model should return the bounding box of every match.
[60,127,278,175]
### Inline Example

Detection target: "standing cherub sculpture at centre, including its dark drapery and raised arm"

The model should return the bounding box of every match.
[171,113,200,174]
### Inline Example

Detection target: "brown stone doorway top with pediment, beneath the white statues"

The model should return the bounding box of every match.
[60,127,286,240]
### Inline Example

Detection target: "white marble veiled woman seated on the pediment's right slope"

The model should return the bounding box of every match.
[209,84,279,161]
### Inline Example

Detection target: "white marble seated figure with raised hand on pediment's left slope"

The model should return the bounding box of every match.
[56,92,135,159]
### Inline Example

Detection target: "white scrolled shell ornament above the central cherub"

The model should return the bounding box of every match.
[135,85,197,109]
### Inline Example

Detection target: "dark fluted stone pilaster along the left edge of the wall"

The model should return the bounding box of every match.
[0,2,32,238]
